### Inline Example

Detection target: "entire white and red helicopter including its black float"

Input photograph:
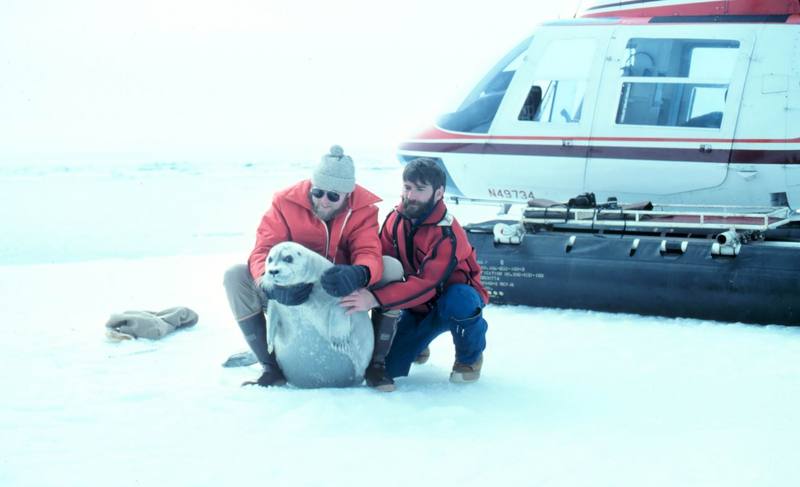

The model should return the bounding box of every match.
[398,0,800,325]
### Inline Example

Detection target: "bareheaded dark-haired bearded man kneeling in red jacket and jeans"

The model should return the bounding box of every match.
[342,158,489,391]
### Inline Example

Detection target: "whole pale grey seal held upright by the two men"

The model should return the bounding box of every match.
[261,242,374,387]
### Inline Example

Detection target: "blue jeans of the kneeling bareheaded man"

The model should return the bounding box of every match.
[386,284,488,377]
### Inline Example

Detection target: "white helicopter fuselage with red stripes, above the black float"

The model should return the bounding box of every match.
[398,0,800,208]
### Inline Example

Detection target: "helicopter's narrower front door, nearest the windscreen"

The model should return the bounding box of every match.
[485,26,607,199]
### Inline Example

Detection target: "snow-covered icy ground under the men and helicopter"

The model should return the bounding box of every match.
[0,161,800,487]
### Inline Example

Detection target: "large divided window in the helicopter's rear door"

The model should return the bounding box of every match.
[617,38,739,129]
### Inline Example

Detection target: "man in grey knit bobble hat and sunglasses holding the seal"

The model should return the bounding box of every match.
[224,145,383,387]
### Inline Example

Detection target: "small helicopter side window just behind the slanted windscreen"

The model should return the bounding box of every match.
[517,39,595,123]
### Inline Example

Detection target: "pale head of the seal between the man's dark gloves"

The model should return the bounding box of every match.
[262,242,324,288]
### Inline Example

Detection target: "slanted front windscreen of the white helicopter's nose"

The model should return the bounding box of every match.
[437,38,532,134]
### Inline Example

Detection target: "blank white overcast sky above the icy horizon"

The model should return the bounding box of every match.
[0,0,572,163]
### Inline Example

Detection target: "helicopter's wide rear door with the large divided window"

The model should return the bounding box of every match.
[586,24,753,203]
